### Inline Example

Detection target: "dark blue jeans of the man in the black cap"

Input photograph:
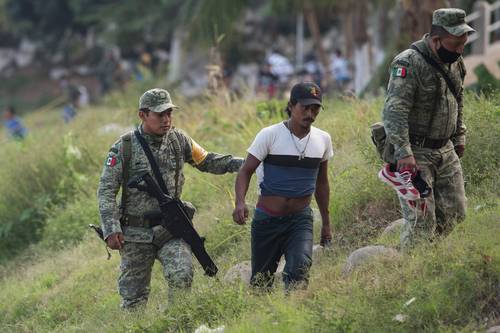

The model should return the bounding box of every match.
[251,206,313,290]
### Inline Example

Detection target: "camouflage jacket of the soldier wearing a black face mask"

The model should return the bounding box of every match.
[383,34,466,160]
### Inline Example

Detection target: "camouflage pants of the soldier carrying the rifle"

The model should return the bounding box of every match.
[118,238,193,308]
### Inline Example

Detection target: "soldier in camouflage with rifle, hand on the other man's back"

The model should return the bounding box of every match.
[98,89,243,308]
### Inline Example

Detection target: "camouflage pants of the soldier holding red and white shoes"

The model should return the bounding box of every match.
[399,148,466,249]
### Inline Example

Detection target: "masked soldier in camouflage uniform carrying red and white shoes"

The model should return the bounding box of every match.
[383,8,474,248]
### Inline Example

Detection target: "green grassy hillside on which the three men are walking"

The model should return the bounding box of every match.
[0,88,500,332]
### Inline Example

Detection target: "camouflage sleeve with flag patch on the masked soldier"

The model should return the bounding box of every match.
[383,51,418,160]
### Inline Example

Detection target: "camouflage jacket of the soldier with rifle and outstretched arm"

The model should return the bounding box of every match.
[97,127,243,242]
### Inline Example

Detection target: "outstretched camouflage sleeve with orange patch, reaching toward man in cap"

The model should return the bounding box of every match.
[183,129,244,175]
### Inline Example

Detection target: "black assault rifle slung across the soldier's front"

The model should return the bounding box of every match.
[128,171,218,276]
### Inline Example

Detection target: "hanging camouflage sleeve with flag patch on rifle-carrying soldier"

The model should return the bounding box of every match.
[97,140,122,239]
